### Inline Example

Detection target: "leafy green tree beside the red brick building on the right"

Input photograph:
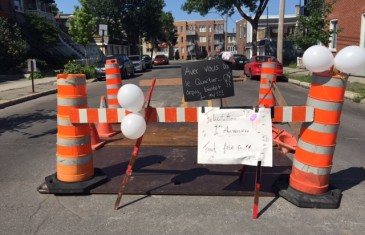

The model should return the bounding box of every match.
[290,0,339,51]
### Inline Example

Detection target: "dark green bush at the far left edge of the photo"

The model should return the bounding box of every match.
[0,17,29,71]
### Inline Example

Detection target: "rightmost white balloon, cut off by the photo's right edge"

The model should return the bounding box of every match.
[335,46,365,73]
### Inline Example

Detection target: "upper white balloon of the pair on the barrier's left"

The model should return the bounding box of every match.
[117,84,144,112]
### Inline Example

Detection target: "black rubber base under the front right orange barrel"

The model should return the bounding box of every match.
[273,175,342,209]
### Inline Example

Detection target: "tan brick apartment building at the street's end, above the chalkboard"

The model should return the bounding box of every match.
[174,20,225,60]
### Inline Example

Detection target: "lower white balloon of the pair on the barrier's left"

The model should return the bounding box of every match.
[121,113,146,140]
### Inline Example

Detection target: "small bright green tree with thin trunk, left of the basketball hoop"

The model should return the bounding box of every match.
[68,0,96,58]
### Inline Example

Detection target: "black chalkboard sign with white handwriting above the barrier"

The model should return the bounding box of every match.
[181,59,234,101]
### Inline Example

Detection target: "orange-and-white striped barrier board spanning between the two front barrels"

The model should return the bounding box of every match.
[70,106,314,123]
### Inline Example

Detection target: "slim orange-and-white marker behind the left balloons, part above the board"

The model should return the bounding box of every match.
[105,59,122,108]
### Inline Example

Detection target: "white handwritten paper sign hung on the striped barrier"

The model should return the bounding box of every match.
[198,107,272,166]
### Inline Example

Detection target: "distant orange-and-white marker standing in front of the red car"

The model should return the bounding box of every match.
[259,62,276,108]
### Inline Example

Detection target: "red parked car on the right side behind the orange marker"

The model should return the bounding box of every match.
[244,55,283,79]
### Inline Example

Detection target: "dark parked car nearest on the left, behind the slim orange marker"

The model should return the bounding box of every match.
[95,55,134,81]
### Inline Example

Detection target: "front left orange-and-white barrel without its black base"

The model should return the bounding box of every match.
[57,74,94,182]
